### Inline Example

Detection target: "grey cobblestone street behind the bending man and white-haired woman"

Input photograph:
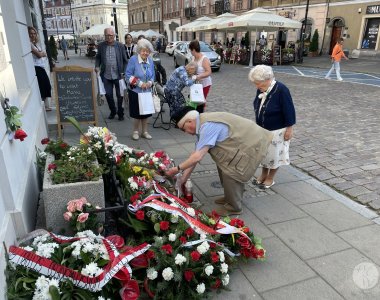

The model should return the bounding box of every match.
[161,54,380,211]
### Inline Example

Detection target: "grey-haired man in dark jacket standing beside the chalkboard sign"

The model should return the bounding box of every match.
[95,27,128,121]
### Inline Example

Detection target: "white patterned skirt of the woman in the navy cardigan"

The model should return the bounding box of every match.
[261,128,290,169]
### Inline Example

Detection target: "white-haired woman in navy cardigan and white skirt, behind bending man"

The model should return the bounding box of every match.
[248,65,296,188]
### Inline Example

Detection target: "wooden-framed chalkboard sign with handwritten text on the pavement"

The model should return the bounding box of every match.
[54,66,98,136]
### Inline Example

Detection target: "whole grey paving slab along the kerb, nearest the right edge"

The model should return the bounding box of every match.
[300,200,372,232]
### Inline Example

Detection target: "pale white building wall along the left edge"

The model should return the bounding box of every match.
[0,0,48,299]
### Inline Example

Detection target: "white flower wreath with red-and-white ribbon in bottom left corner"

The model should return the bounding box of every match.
[6,230,149,300]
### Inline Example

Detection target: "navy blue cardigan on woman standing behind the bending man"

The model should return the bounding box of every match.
[253,81,296,130]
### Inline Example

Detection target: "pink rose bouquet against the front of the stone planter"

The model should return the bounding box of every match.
[63,197,102,233]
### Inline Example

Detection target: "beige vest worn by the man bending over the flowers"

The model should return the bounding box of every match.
[200,112,273,182]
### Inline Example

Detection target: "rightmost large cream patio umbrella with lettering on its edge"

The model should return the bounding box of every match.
[216,7,302,67]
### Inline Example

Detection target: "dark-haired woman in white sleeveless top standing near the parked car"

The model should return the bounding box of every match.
[189,40,212,113]
